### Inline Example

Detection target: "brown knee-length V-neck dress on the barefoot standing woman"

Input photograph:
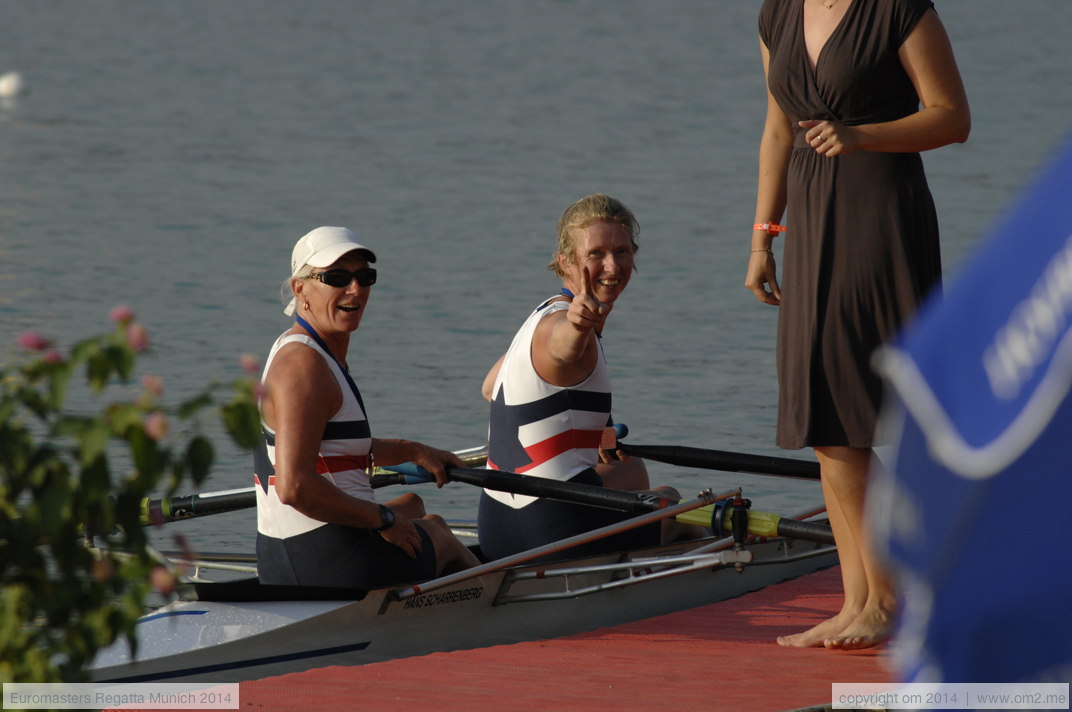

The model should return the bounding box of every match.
[759,0,941,448]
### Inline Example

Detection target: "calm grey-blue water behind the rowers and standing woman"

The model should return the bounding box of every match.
[0,0,1072,550]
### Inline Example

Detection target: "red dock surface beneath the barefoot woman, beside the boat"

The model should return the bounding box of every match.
[230,567,892,712]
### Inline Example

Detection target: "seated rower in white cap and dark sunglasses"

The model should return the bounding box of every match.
[254,227,479,589]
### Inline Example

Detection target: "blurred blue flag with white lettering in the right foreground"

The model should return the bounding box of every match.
[868,133,1072,683]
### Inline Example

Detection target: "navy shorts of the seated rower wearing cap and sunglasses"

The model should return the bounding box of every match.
[257,523,435,589]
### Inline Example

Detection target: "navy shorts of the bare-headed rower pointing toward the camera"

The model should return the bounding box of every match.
[477,470,662,561]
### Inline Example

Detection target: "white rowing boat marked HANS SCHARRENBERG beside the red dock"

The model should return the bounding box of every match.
[90,493,836,682]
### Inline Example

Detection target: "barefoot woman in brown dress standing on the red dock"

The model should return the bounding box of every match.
[745,0,971,648]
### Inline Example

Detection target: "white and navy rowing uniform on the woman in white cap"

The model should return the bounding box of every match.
[253,333,435,588]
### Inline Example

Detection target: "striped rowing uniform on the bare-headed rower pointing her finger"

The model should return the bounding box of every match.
[478,298,659,560]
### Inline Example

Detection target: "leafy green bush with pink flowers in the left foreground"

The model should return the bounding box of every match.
[0,307,259,682]
